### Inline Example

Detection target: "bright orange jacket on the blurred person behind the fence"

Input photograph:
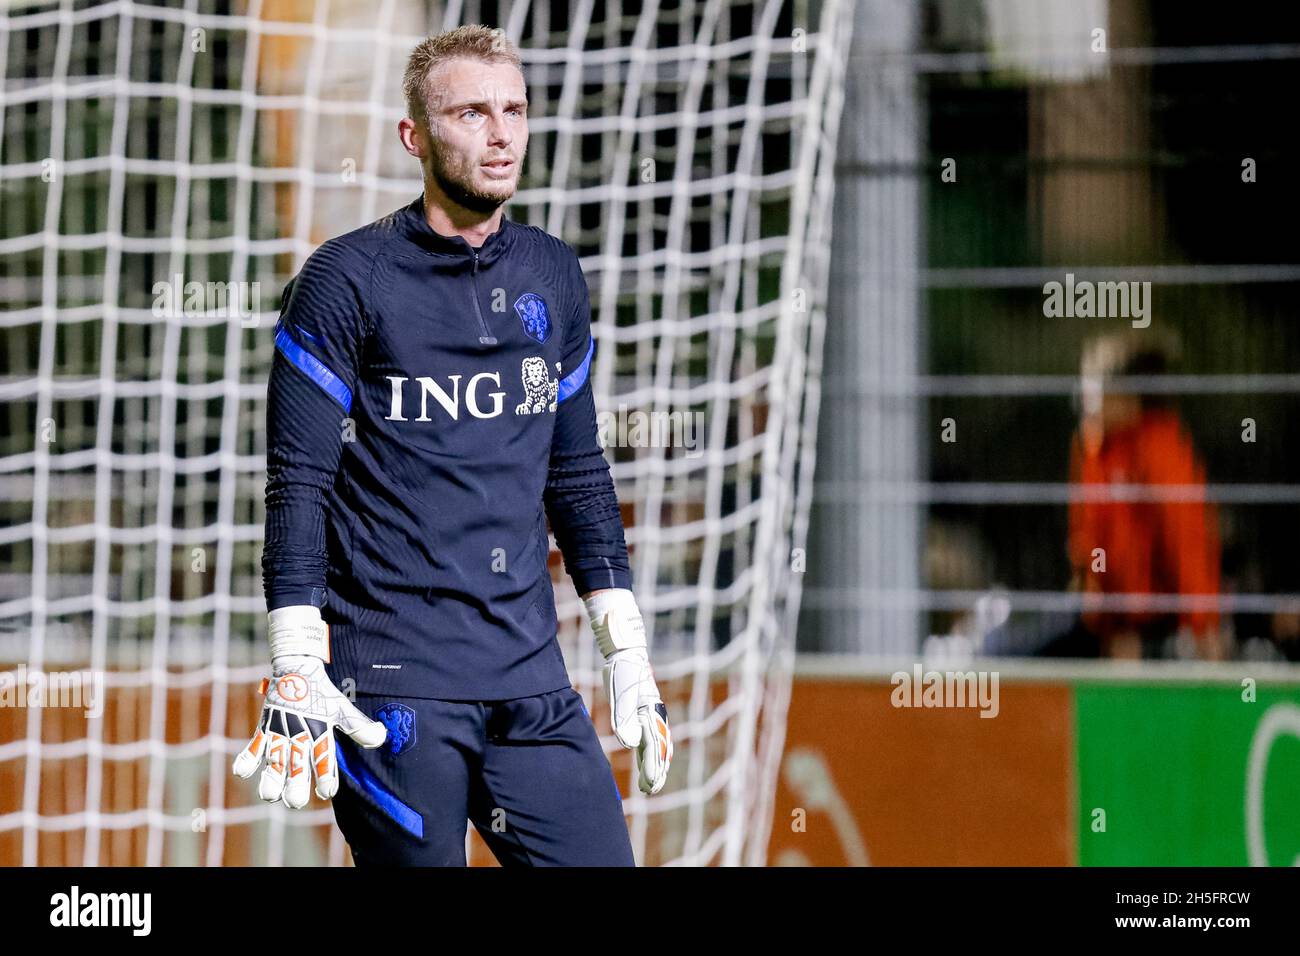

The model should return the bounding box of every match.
[1069,410,1219,635]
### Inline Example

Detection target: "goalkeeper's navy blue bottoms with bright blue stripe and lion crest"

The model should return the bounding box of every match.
[333,687,636,866]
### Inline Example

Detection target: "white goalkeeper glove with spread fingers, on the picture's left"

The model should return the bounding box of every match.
[234,605,389,809]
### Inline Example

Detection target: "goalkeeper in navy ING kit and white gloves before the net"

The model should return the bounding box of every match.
[234,26,672,866]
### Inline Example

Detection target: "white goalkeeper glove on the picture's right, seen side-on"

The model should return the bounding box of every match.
[582,588,672,793]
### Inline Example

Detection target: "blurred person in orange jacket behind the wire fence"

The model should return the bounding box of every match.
[1069,330,1227,659]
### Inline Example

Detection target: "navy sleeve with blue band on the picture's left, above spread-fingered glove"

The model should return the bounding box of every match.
[261,243,365,610]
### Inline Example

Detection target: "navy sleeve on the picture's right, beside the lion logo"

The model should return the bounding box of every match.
[543,256,632,594]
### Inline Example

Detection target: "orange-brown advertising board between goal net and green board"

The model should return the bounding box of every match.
[768,678,1076,866]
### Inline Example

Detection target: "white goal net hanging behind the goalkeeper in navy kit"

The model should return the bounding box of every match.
[0,0,852,866]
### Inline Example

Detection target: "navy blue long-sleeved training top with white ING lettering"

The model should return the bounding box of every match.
[263,195,632,700]
